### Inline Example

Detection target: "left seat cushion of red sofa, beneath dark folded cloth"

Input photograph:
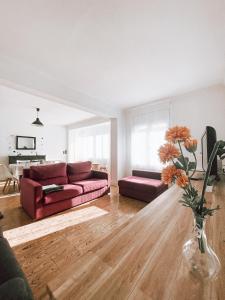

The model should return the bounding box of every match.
[44,184,83,204]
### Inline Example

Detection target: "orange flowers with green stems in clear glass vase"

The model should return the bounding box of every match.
[159,126,224,280]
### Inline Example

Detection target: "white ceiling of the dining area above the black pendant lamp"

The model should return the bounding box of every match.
[0,85,94,126]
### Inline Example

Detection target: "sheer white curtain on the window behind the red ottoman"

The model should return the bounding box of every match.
[127,103,170,173]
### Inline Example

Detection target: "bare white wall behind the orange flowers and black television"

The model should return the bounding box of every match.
[171,85,225,169]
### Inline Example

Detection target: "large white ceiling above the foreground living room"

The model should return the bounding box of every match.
[0,0,225,108]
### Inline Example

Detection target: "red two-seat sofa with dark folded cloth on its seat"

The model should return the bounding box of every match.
[20,161,110,220]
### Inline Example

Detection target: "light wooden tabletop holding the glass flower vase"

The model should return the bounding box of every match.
[48,181,225,300]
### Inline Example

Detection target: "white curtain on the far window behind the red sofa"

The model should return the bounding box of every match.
[68,122,110,166]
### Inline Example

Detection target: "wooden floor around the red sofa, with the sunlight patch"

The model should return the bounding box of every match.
[0,188,146,299]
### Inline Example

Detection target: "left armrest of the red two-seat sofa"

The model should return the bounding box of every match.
[20,178,43,219]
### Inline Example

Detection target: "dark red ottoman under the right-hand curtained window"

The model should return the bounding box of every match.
[118,170,168,202]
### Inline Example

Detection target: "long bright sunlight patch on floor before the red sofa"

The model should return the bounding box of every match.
[3,206,108,247]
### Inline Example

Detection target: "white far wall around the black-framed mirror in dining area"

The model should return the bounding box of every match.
[0,103,67,164]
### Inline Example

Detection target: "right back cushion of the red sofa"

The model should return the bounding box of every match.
[67,161,92,183]
